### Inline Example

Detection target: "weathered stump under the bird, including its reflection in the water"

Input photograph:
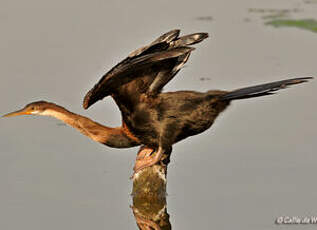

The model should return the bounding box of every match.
[131,148,171,230]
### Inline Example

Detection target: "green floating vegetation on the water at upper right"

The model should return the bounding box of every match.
[265,19,317,33]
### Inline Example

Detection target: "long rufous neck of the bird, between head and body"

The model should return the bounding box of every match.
[41,103,139,148]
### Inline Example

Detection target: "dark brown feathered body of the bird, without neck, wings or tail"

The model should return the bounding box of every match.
[115,91,230,148]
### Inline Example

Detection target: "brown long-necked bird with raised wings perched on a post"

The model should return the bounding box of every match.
[5,30,311,171]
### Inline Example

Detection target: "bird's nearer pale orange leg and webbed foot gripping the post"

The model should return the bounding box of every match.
[134,146,164,173]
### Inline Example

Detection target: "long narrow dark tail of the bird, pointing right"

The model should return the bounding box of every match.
[221,77,313,100]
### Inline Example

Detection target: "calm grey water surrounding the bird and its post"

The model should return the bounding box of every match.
[0,0,317,230]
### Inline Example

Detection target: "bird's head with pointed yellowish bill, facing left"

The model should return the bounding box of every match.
[3,101,53,117]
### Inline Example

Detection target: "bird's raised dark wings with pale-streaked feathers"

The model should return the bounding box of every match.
[83,30,208,109]
